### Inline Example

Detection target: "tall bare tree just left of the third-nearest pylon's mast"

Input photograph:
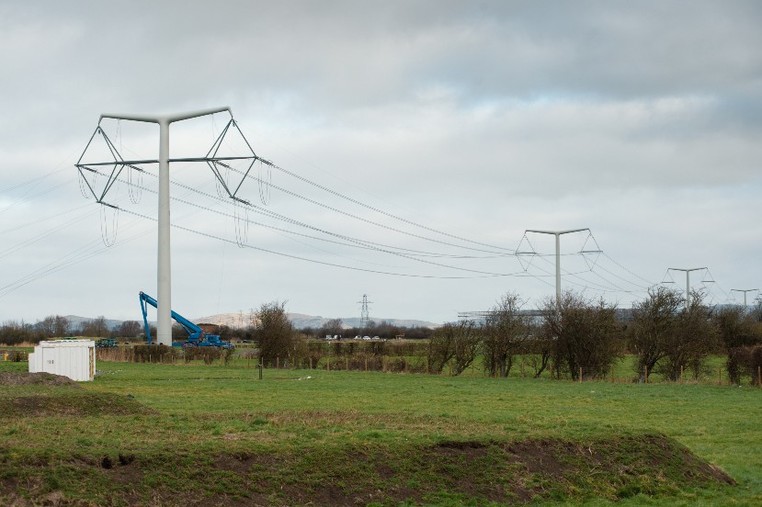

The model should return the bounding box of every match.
[627,287,685,381]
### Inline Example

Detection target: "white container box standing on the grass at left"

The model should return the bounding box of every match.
[29,340,95,382]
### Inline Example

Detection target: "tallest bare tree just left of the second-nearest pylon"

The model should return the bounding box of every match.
[483,293,532,377]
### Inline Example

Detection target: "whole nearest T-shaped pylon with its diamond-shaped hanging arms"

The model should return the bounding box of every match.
[75,107,264,346]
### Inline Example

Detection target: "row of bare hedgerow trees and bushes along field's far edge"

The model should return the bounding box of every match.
[245,287,762,383]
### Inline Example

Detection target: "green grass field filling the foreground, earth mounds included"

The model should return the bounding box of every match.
[0,362,762,505]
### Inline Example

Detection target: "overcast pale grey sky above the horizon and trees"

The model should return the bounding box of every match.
[0,0,762,322]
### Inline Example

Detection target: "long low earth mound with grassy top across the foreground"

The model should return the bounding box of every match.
[0,435,734,507]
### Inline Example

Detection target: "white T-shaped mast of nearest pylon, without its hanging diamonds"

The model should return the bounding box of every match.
[101,107,233,347]
